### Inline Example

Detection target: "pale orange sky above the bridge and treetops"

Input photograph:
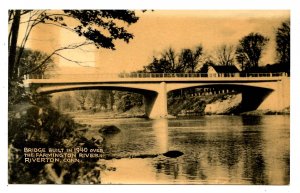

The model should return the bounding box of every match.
[21,10,290,74]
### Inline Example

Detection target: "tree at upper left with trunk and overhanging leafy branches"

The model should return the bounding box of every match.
[8,10,138,80]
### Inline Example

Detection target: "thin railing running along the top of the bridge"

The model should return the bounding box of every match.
[24,72,287,79]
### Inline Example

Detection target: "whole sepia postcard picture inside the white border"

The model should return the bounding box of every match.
[7,9,293,186]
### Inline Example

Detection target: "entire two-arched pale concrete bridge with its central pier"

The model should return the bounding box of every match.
[24,73,290,119]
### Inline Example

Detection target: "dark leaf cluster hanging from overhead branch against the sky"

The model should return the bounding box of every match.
[64,10,138,49]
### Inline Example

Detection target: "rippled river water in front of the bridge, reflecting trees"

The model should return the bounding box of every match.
[82,115,290,185]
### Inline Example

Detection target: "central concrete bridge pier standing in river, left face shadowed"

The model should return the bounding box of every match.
[144,82,168,119]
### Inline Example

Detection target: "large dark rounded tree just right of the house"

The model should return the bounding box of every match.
[235,33,269,70]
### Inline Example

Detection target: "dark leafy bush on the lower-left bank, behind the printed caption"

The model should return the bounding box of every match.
[8,103,101,184]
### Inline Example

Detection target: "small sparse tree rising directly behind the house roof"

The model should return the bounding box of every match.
[216,44,234,66]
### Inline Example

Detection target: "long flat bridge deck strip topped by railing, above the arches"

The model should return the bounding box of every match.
[24,73,286,84]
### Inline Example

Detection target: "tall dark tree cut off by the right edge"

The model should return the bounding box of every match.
[276,20,290,71]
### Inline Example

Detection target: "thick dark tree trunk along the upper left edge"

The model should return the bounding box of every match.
[8,10,21,80]
